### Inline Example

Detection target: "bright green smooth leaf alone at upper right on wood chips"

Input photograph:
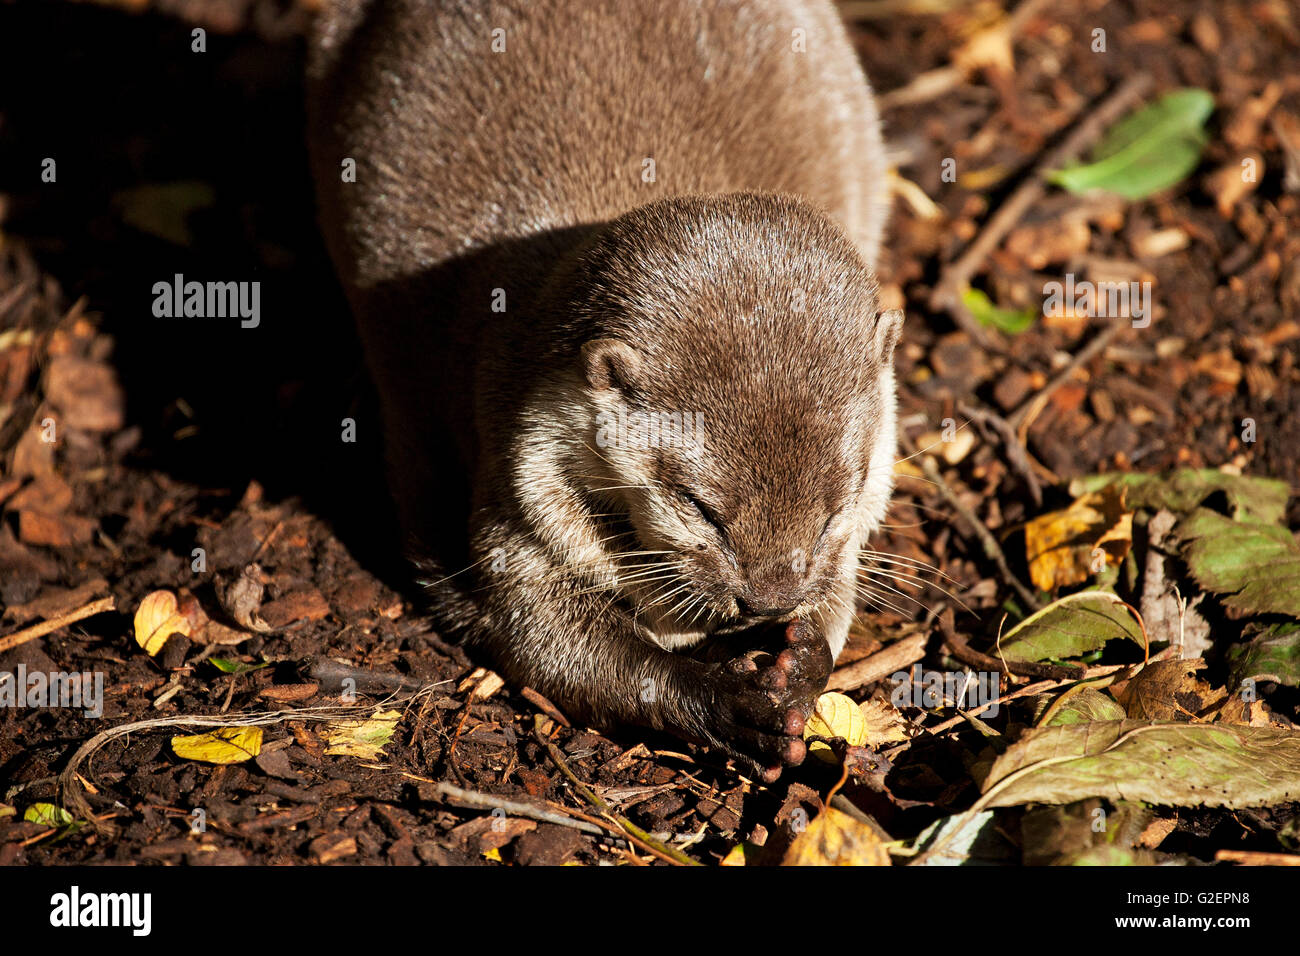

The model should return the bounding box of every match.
[1048,88,1214,199]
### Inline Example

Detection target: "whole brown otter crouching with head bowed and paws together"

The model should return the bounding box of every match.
[308,0,902,780]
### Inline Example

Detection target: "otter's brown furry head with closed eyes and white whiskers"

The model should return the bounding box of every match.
[577,194,901,631]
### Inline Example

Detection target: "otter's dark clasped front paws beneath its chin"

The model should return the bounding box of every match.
[707,622,832,783]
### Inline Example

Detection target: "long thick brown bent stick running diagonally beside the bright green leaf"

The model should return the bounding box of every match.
[930,73,1152,351]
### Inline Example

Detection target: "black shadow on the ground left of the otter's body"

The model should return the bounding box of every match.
[0,3,407,587]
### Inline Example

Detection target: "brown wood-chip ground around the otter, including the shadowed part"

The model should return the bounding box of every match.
[0,0,1300,865]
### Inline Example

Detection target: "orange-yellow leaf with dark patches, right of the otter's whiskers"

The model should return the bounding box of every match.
[1024,485,1134,591]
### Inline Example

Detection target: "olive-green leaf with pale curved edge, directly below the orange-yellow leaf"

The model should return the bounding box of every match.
[998,591,1145,661]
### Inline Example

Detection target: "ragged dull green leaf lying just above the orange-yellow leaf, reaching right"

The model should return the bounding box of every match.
[1070,468,1291,524]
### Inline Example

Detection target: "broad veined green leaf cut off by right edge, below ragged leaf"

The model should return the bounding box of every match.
[1174,507,1300,618]
